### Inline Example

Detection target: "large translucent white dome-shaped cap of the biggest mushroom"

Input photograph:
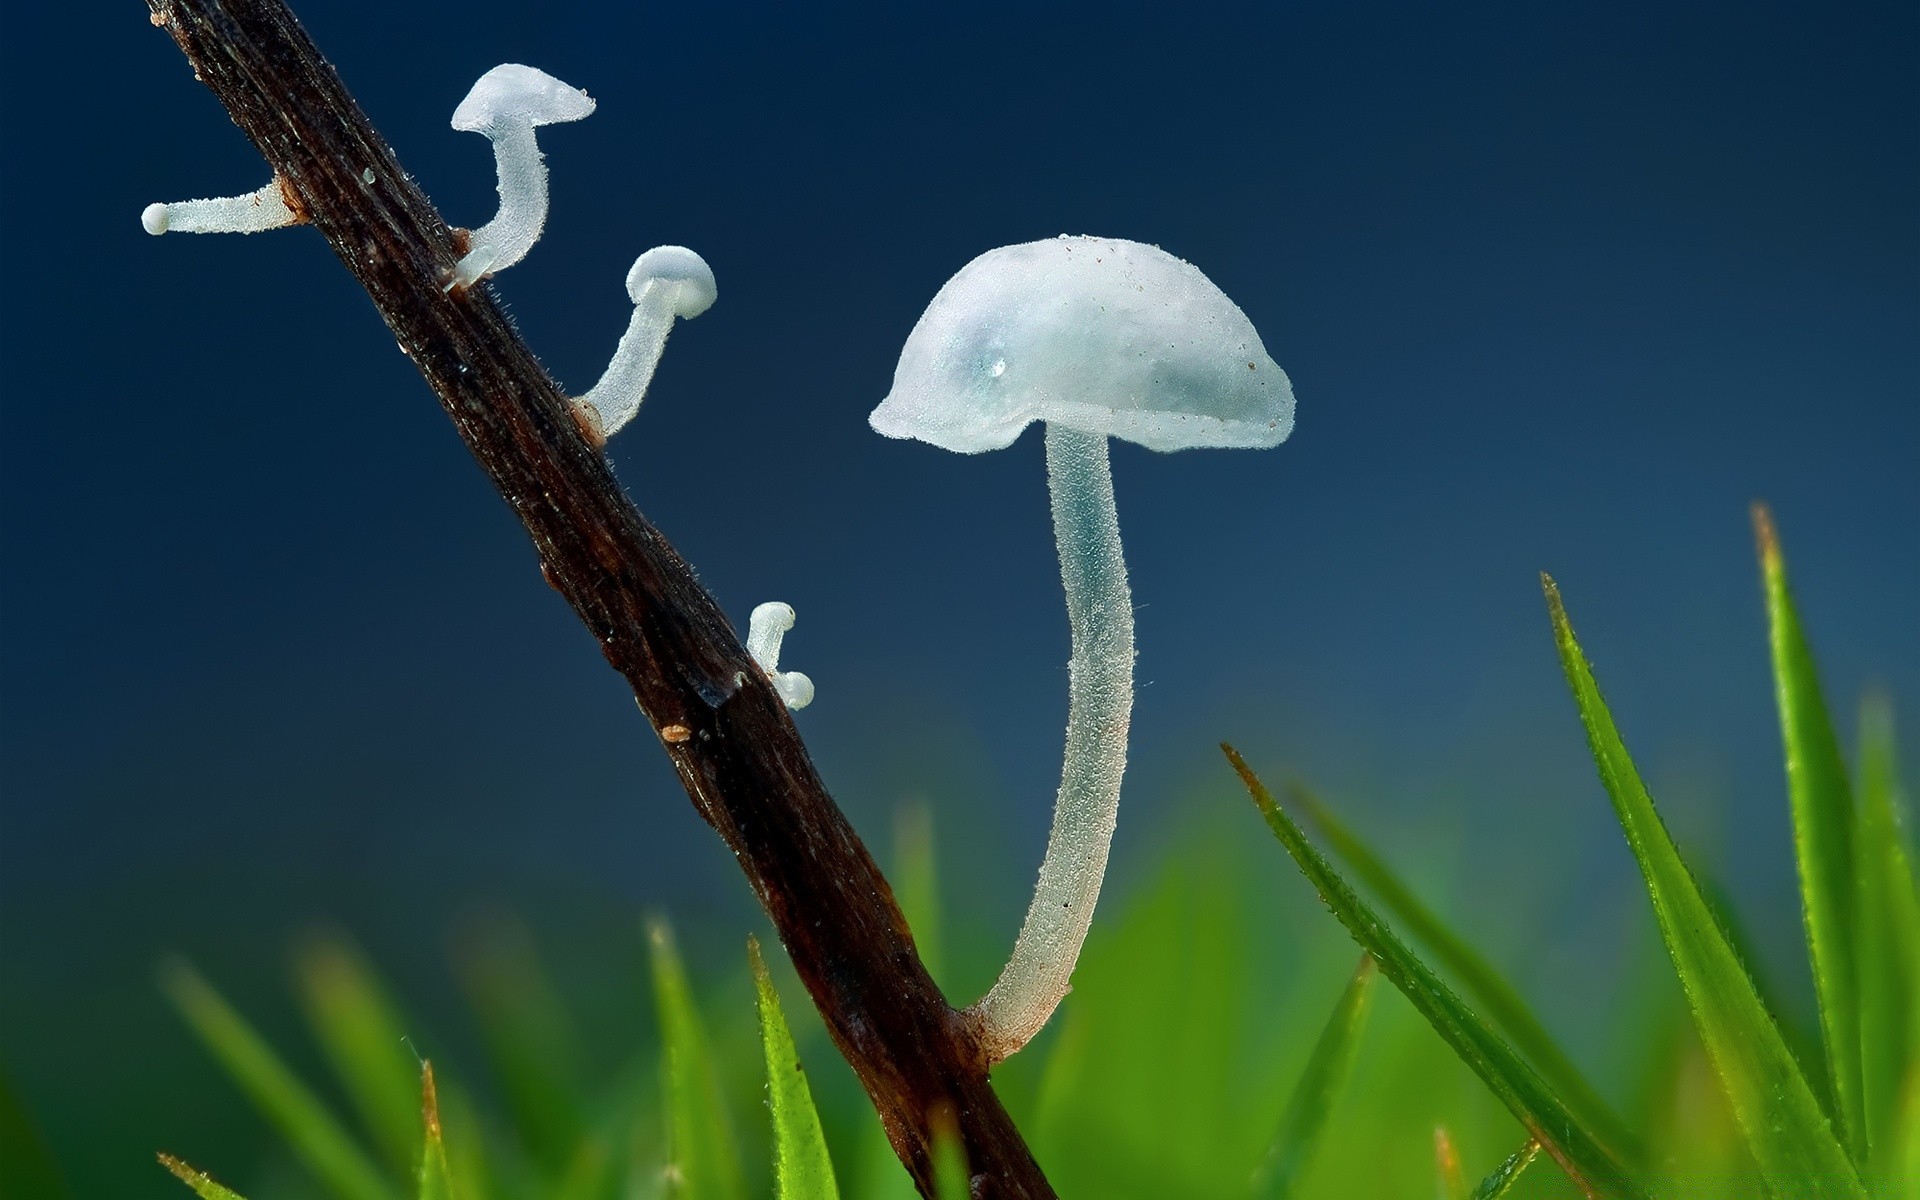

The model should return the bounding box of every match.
[868,234,1294,453]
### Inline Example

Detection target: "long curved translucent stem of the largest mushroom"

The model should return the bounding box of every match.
[966,422,1133,1064]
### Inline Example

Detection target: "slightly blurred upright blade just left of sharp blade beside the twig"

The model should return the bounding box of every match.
[647,922,747,1200]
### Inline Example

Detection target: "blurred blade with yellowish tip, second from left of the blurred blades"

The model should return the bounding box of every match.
[294,933,420,1175]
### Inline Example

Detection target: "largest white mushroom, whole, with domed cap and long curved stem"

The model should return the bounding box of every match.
[868,236,1294,1062]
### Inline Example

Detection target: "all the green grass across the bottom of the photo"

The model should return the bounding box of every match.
[0,516,1920,1200]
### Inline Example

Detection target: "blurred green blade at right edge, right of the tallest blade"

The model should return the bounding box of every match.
[1853,697,1920,1175]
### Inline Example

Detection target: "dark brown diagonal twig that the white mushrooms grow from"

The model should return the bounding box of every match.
[148,0,1054,1198]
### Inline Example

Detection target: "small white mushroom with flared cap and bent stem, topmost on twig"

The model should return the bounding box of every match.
[449,63,593,290]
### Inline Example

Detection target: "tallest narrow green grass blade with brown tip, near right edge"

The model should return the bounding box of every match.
[1753,503,1866,1162]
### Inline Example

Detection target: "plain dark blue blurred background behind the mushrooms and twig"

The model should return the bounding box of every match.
[0,0,1920,1188]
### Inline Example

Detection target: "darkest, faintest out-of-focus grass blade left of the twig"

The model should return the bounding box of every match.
[459,920,588,1179]
